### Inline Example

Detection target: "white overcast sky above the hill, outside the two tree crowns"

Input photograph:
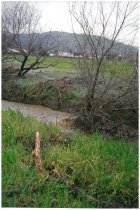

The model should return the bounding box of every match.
[33,1,138,45]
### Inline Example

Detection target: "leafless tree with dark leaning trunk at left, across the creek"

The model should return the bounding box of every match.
[2,2,58,77]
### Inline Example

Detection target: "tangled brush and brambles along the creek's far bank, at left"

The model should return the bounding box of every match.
[2,79,76,109]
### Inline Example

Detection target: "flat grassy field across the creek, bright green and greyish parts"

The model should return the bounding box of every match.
[3,53,133,103]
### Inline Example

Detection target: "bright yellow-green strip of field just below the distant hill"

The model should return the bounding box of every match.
[4,55,133,74]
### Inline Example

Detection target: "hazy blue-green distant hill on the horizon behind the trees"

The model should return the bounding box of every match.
[11,31,138,56]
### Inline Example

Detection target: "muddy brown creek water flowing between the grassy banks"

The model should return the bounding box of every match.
[2,100,75,129]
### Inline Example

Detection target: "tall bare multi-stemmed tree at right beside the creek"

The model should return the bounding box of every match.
[70,2,137,132]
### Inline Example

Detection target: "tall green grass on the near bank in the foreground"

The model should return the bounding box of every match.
[2,110,138,208]
